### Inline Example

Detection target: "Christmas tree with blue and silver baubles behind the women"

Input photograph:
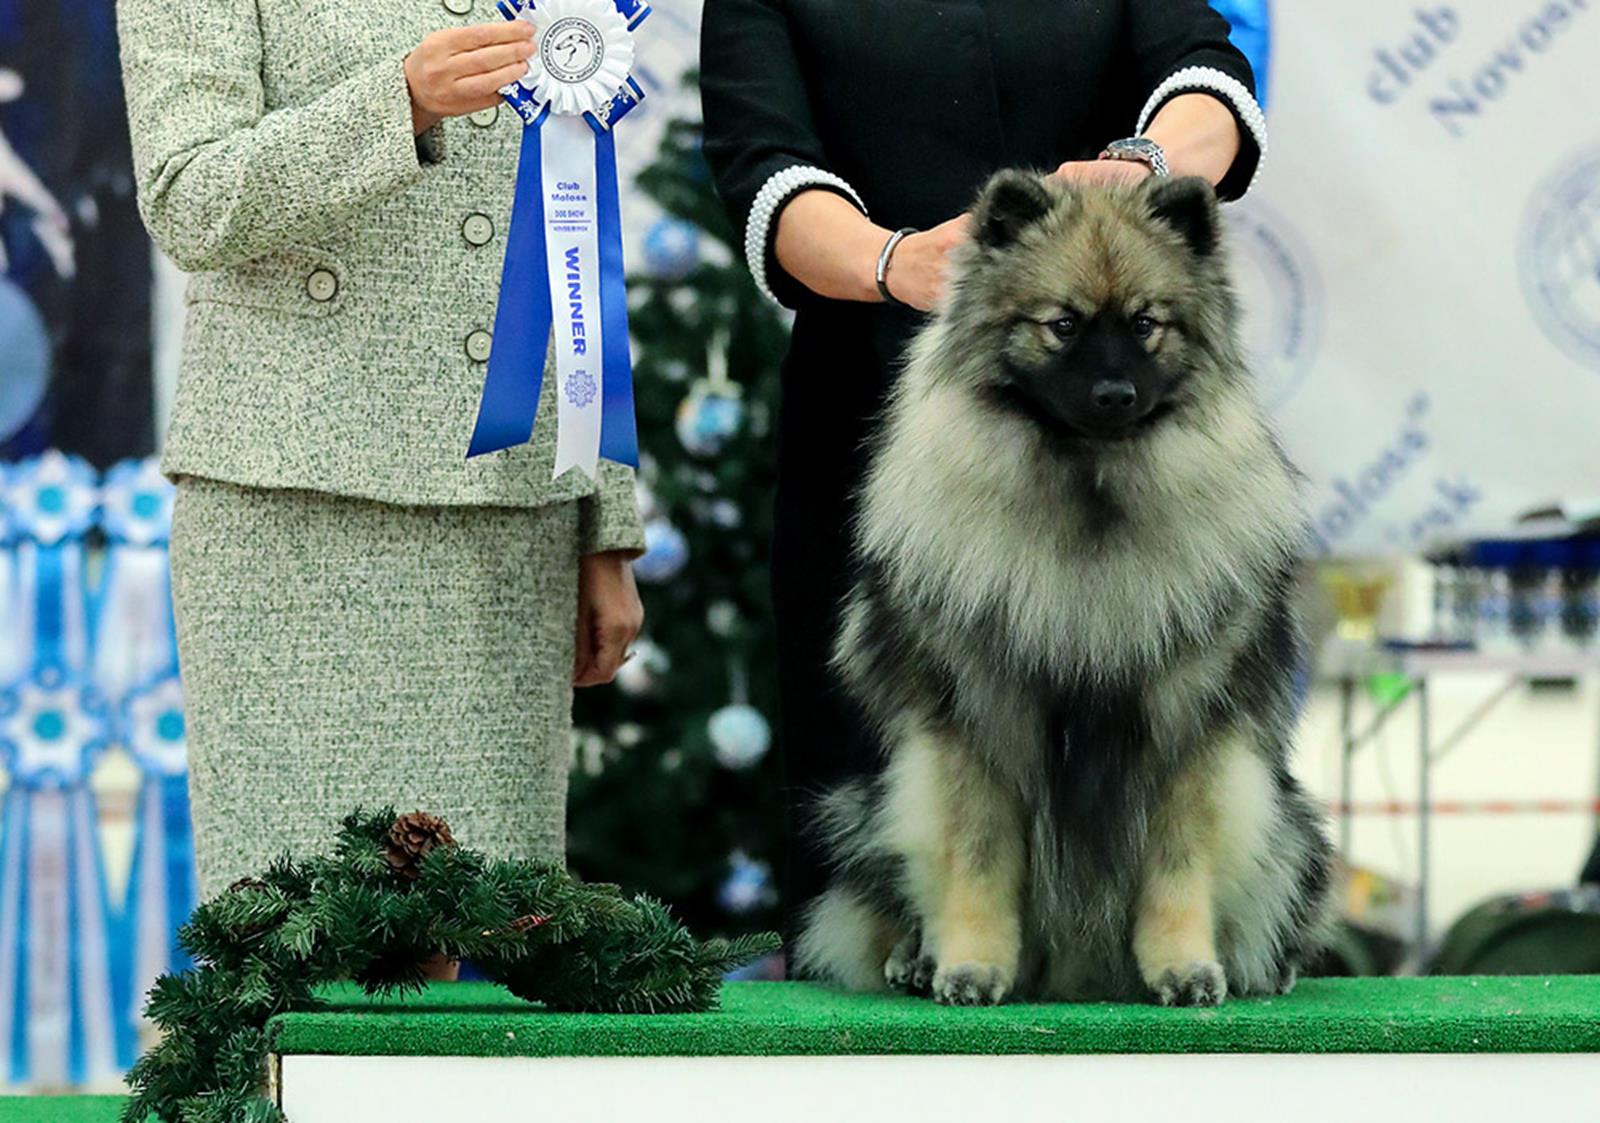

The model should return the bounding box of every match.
[568,96,787,934]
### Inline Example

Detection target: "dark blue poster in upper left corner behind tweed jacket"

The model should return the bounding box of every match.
[0,0,154,467]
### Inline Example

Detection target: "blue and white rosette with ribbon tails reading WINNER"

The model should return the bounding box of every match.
[467,0,650,478]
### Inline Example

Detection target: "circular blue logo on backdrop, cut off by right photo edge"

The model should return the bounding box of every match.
[1518,147,1600,370]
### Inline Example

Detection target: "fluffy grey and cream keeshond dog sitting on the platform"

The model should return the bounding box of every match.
[797,171,1331,1006]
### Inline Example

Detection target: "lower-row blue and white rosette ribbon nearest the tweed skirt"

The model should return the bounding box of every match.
[118,673,198,1024]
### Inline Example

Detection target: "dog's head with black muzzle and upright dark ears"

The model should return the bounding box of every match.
[946,173,1232,451]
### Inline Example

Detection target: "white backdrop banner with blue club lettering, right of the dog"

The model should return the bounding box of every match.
[1218,0,1600,555]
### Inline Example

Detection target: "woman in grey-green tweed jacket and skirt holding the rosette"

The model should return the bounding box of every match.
[117,0,643,915]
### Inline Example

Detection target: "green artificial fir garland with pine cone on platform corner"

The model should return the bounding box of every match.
[123,809,778,1123]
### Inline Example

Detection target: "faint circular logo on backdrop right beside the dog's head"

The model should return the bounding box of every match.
[1226,197,1323,410]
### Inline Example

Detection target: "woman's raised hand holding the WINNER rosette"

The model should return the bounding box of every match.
[405,19,536,134]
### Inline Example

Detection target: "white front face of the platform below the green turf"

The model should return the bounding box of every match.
[282,1054,1600,1123]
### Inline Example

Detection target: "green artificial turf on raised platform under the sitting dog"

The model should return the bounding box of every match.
[269,976,1600,1057]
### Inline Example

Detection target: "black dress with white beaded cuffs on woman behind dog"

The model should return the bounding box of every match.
[701,0,1264,934]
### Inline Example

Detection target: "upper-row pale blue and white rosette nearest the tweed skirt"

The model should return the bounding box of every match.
[93,458,178,704]
